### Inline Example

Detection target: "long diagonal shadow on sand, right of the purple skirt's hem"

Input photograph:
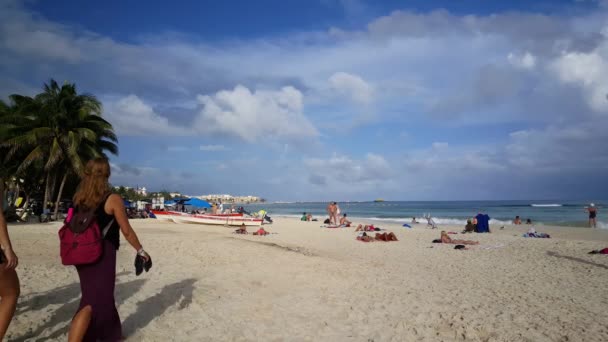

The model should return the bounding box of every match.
[122,279,196,336]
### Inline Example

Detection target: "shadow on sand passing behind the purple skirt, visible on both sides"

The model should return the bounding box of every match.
[11,279,146,341]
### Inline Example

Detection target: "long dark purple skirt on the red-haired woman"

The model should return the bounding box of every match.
[76,240,122,342]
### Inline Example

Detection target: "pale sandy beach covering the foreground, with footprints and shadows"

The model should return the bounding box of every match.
[8,218,608,341]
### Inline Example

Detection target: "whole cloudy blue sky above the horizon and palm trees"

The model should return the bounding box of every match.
[0,0,608,201]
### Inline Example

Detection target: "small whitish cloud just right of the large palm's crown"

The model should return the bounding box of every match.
[104,95,192,136]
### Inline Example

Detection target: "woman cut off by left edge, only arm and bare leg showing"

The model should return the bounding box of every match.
[0,208,19,341]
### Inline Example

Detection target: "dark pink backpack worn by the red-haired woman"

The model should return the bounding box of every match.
[59,197,114,265]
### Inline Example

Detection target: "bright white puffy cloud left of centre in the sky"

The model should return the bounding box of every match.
[194,85,319,142]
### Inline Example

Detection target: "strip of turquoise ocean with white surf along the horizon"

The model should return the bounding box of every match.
[244,200,608,229]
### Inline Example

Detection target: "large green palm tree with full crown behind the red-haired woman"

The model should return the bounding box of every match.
[2,80,118,217]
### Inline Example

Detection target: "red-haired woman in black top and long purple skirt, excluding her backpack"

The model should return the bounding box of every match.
[68,158,150,342]
